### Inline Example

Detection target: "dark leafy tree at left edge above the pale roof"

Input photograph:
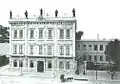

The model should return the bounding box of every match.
[0,25,9,43]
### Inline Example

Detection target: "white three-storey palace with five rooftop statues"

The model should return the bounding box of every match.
[9,9,77,73]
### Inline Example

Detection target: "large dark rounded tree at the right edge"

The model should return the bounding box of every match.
[105,39,120,70]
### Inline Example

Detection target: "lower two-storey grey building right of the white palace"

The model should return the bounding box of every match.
[76,40,109,64]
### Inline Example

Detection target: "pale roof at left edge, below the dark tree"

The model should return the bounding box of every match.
[0,43,9,55]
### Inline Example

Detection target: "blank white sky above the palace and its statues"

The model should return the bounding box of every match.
[0,0,120,39]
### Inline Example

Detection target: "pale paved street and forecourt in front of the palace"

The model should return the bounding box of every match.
[0,65,120,84]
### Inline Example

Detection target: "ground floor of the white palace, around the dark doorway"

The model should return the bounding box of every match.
[10,56,76,73]
